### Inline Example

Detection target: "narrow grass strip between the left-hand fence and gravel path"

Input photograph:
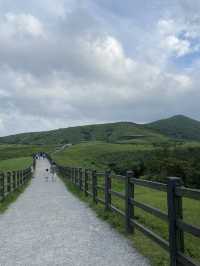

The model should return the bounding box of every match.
[0,181,30,214]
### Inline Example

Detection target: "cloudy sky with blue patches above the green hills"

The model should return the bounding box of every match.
[0,0,200,136]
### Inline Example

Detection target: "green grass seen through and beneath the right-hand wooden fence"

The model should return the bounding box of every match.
[59,172,200,266]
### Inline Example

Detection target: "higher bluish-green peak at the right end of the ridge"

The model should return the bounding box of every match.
[145,115,200,141]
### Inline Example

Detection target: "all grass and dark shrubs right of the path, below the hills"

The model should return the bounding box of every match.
[53,139,200,266]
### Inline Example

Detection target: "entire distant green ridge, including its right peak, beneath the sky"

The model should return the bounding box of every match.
[0,115,200,145]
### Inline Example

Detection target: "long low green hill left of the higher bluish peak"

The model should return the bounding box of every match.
[0,122,166,145]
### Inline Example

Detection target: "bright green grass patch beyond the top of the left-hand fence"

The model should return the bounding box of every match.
[0,157,32,171]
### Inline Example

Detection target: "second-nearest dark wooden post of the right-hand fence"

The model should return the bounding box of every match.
[125,171,134,233]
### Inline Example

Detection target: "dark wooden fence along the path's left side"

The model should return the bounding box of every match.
[0,166,32,201]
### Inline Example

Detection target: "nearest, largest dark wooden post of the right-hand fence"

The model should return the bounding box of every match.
[167,177,184,266]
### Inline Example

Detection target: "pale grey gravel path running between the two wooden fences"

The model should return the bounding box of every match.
[0,160,148,266]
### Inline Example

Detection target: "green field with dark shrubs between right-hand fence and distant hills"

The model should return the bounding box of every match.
[53,142,200,188]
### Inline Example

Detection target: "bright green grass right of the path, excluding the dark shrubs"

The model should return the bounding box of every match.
[53,142,200,265]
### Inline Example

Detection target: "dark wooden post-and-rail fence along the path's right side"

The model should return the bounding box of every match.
[50,158,200,266]
